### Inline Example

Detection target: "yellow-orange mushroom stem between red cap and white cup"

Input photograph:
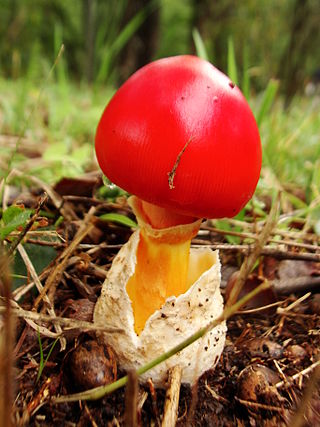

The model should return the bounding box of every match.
[127,196,204,335]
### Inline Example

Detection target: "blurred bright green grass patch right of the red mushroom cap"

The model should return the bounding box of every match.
[260,98,320,193]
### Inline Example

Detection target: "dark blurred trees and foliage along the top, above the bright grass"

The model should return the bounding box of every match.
[0,0,320,103]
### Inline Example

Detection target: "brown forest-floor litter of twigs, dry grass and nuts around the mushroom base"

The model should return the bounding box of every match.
[0,171,320,426]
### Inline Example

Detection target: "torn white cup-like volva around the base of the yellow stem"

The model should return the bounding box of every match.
[94,230,226,387]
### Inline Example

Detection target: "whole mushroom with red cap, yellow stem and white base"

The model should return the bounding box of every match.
[94,55,261,385]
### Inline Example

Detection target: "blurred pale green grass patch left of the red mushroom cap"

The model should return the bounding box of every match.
[0,79,113,183]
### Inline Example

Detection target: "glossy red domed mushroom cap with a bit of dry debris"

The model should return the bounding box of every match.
[96,55,261,218]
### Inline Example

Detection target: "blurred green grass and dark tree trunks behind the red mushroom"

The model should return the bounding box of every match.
[0,0,320,197]
